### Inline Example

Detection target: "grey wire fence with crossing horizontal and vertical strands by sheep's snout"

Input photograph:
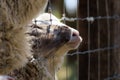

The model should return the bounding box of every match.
[32,0,120,80]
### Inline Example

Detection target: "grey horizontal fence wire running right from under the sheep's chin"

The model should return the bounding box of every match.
[67,45,120,56]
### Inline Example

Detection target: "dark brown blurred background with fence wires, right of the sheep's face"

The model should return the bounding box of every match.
[45,0,120,80]
